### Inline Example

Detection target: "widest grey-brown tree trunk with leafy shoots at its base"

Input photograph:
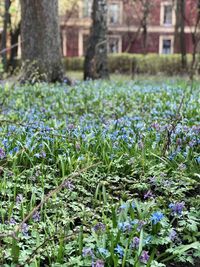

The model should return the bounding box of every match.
[21,0,63,82]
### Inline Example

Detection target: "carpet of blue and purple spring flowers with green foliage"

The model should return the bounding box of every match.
[0,81,200,267]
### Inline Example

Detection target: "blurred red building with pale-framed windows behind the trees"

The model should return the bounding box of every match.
[61,0,197,57]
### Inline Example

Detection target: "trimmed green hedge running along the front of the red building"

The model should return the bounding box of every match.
[64,53,191,75]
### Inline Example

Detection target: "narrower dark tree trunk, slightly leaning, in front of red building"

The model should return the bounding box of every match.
[84,0,109,80]
